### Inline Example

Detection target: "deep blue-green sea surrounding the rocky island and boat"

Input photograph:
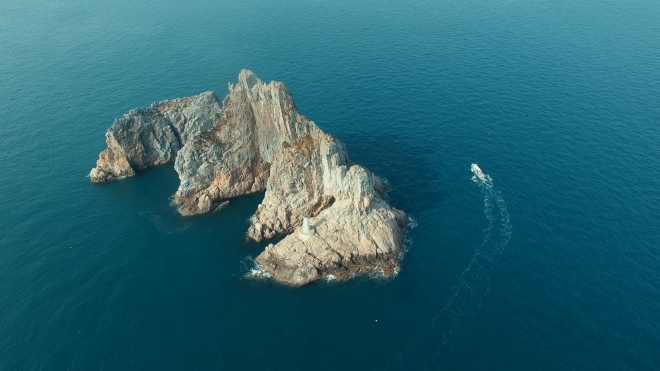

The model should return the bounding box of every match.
[0,0,660,371]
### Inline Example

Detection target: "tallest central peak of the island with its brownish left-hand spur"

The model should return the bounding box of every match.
[174,70,318,215]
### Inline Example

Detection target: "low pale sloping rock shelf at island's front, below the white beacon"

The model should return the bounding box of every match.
[256,196,408,286]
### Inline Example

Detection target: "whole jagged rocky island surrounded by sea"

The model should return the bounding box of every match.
[89,70,408,286]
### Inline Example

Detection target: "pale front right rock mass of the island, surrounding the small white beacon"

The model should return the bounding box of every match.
[248,131,408,285]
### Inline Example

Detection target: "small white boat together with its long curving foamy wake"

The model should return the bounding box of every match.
[390,164,511,369]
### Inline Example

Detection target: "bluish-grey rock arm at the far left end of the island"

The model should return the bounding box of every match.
[89,92,221,183]
